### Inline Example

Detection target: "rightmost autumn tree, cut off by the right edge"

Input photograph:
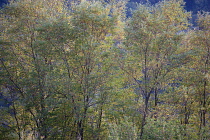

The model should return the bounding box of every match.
[178,12,210,139]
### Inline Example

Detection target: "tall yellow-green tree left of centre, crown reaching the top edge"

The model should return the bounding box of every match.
[65,1,125,139]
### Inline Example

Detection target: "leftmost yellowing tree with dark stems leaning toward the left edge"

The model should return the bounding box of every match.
[1,0,70,139]
